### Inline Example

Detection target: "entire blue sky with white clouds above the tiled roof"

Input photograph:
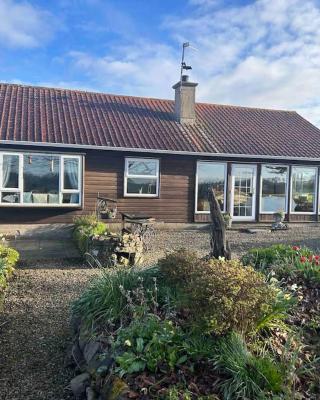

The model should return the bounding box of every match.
[0,0,320,126]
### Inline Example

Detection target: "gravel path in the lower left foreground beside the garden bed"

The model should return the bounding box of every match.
[0,261,97,400]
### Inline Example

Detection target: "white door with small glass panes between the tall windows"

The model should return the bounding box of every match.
[231,164,257,221]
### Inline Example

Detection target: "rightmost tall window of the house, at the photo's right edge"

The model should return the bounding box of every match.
[291,167,317,213]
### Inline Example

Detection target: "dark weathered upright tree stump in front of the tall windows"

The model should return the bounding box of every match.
[208,189,231,260]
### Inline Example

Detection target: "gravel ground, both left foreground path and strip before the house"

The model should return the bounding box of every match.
[0,224,320,400]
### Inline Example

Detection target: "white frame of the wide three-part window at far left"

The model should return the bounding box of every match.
[0,150,83,208]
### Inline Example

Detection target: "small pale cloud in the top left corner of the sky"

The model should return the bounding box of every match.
[0,0,55,48]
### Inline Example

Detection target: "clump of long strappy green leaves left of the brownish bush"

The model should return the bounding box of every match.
[73,268,174,329]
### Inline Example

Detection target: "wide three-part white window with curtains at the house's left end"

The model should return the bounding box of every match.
[0,152,81,207]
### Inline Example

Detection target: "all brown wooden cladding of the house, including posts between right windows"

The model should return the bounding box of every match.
[0,145,318,224]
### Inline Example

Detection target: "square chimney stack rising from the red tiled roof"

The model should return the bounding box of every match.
[172,75,198,125]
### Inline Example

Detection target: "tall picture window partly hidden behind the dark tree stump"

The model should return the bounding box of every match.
[196,161,227,213]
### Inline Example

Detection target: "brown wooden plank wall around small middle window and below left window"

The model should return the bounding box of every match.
[0,149,196,223]
